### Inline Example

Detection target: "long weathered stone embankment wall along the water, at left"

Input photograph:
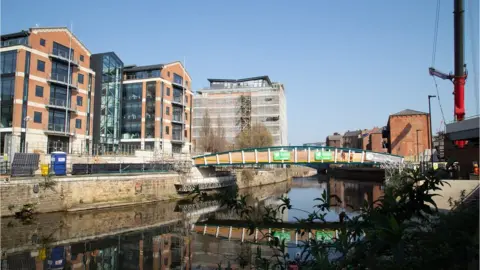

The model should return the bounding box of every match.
[0,174,178,216]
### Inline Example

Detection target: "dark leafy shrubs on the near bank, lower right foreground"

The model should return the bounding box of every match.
[192,170,479,270]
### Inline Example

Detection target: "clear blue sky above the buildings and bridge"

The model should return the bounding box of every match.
[1,0,479,144]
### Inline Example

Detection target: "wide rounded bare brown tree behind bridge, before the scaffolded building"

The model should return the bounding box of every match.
[235,123,273,148]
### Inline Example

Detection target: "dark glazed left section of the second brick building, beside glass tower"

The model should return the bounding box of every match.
[122,83,142,139]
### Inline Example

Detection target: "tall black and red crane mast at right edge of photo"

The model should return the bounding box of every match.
[428,0,467,148]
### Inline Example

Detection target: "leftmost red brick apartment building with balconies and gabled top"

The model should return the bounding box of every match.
[0,27,95,152]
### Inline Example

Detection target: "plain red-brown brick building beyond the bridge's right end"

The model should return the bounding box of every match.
[382,109,430,156]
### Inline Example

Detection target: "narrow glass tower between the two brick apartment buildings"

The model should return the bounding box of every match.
[96,54,122,149]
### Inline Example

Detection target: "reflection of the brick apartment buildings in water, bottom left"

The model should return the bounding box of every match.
[1,230,191,270]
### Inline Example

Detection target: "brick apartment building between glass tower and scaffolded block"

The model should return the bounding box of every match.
[120,62,192,152]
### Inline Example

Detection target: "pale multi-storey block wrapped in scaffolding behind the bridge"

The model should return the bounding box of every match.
[192,76,288,146]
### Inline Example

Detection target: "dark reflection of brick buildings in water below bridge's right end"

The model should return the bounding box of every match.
[329,179,383,212]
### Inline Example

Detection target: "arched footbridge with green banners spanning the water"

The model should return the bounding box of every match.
[193,146,403,166]
